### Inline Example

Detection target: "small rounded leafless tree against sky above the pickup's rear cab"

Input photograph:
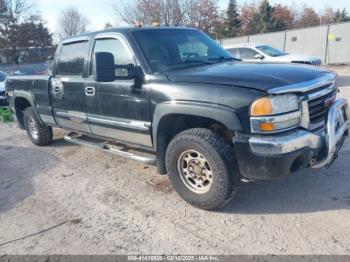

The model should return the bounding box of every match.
[58,7,89,38]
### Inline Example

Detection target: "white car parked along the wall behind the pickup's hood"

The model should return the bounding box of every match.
[224,43,322,66]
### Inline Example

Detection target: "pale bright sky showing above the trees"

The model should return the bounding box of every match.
[34,0,350,36]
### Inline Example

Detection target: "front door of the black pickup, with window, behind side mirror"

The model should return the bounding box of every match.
[85,33,152,147]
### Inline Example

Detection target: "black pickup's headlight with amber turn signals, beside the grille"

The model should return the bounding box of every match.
[250,95,301,133]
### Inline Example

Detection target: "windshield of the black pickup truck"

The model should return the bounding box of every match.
[132,29,234,72]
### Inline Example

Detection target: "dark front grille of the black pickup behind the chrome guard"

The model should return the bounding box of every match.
[308,92,336,125]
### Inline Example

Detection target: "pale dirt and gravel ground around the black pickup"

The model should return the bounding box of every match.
[0,67,350,255]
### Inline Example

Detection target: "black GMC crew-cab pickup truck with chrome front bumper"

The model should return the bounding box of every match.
[6,27,350,210]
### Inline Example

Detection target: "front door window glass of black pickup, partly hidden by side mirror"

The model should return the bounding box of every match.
[90,39,134,76]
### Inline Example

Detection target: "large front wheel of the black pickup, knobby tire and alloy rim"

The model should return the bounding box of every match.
[166,128,240,210]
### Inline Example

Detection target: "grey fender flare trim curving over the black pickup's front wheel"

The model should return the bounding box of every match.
[152,101,243,148]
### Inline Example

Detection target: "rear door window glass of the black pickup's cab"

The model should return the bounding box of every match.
[57,41,89,76]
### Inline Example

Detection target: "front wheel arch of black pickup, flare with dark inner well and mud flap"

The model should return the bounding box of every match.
[152,102,242,174]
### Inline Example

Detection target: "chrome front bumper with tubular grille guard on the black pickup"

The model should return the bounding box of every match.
[249,99,350,168]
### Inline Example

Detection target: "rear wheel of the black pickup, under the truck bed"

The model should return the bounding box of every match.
[23,107,53,146]
